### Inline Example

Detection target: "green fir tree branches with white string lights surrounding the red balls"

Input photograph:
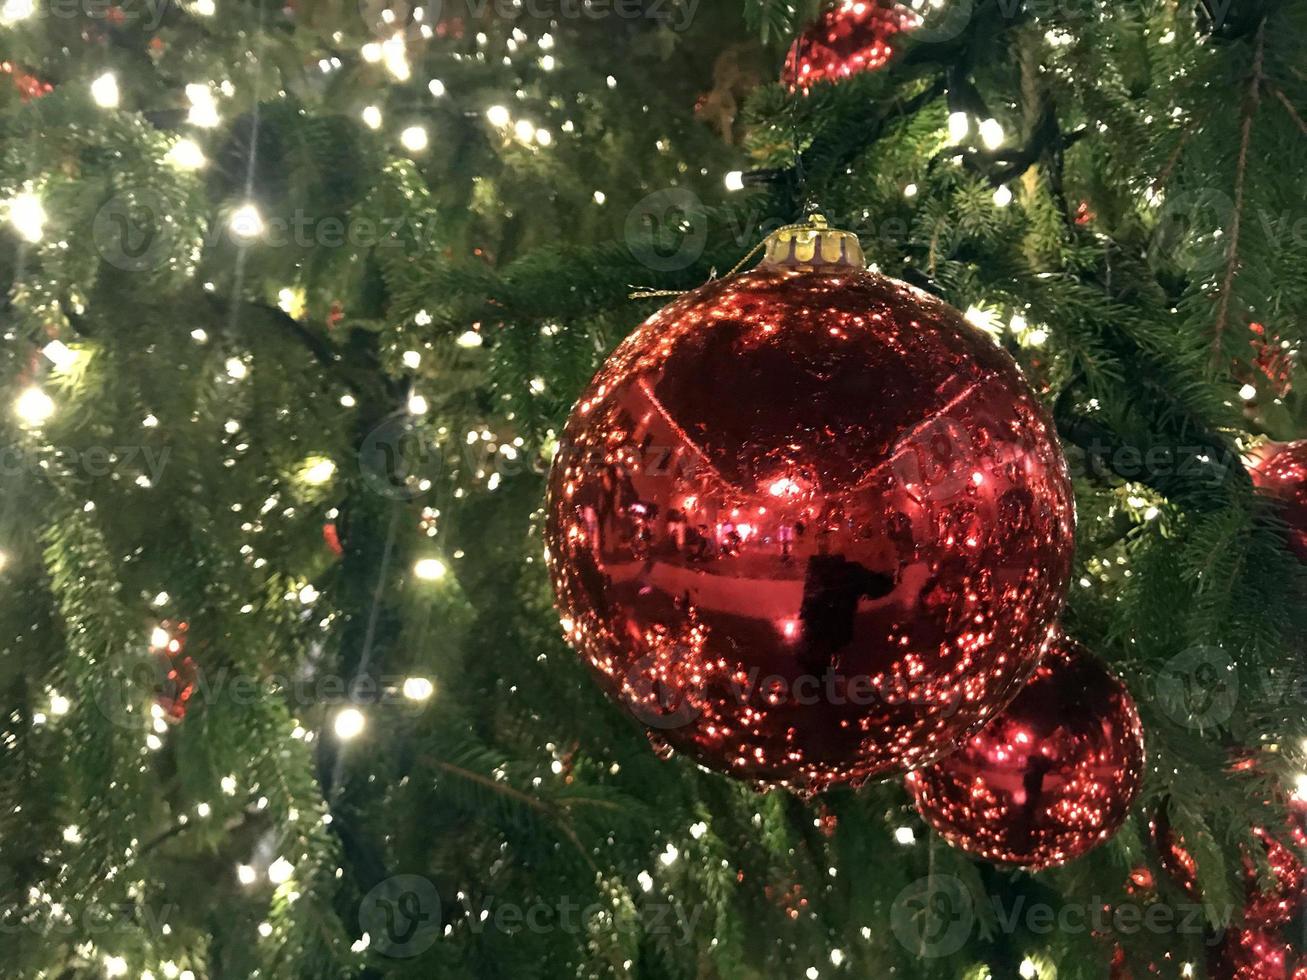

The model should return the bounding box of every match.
[0,0,1307,980]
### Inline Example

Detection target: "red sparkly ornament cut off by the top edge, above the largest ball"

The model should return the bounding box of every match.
[780,0,921,93]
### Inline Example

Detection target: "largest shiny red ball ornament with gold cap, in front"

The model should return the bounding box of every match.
[546,220,1074,791]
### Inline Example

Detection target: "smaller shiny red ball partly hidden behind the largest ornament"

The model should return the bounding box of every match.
[907,638,1144,869]
